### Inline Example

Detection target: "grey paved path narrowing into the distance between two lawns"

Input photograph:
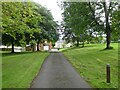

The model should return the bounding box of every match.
[31,53,90,88]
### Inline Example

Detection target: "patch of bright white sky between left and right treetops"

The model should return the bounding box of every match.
[33,0,62,22]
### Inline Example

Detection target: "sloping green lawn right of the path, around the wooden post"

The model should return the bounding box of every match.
[63,43,118,88]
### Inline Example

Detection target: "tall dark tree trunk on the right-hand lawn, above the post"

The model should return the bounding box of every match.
[103,2,111,49]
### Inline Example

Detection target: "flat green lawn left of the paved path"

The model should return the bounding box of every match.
[2,52,49,88]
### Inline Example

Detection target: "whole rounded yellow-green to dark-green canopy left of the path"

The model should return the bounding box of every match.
[2,2,57,52]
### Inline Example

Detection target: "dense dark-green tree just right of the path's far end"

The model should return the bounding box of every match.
[63,2,92,47]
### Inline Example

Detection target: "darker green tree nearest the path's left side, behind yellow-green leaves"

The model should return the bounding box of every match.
[35,4,58,51]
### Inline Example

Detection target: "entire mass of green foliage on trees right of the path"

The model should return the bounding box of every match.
[61,1,119,48]
